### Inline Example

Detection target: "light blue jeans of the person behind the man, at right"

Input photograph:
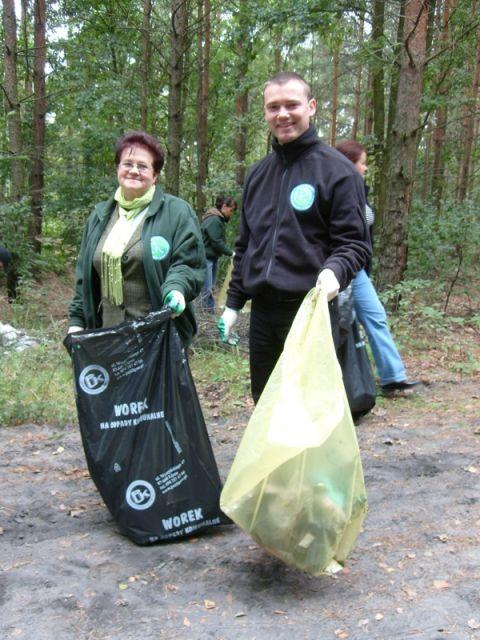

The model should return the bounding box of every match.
[352,269,407,385]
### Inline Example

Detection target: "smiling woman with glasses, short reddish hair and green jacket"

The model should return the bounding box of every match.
[69,131,205,346]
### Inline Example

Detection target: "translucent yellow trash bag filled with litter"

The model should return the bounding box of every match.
[220,290,367,575]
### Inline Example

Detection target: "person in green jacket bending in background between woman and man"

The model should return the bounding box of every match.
[200,196,237,313]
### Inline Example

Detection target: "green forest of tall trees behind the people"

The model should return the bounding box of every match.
[0,0,480,312]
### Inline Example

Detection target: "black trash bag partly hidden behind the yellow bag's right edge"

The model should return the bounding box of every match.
[337,320,377,419]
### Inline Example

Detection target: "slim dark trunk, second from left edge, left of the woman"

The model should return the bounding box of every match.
[29,0,47,253]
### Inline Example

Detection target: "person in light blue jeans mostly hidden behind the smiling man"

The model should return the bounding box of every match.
[336,140,419,395]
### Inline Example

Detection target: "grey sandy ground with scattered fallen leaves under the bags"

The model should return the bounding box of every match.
[0,276,480,640]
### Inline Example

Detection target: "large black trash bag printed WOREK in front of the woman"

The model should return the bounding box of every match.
[64,310,231,545]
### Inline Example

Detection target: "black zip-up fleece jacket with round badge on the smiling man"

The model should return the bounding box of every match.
[227,126,371,309]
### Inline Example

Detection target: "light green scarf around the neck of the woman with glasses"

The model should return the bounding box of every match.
[101,185,155,306]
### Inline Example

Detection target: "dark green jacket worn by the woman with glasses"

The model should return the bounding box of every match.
[69,187,205,345]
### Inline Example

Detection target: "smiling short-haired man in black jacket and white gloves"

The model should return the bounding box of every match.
[218,72,370,402]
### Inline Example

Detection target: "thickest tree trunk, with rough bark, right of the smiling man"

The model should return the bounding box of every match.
[378,0,428,296]
